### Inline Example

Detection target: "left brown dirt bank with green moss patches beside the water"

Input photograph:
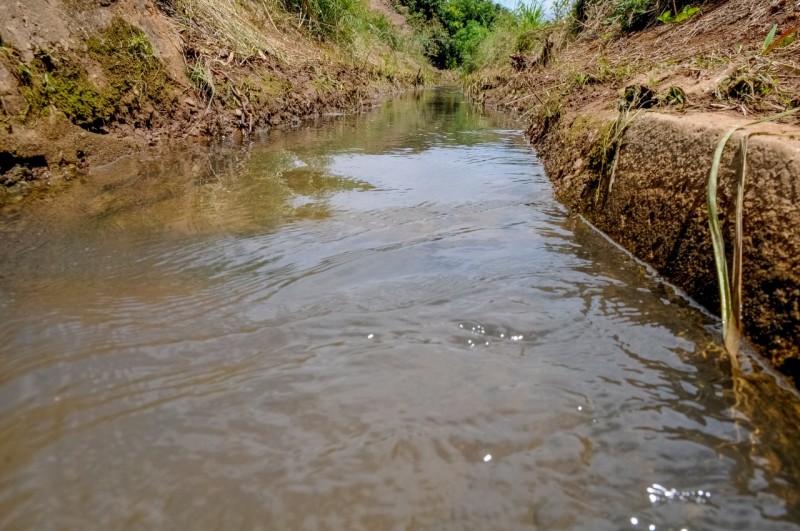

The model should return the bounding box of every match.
[0,0,436,203]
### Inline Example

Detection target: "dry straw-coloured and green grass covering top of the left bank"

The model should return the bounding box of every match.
[164,0,429,75]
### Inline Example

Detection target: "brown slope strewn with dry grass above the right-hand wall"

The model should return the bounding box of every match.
[470,0,800,126]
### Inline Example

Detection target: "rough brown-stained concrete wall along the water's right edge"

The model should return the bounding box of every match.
[535,113,800,383]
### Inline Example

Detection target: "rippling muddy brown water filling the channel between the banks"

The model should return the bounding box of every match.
[0,89,800,530]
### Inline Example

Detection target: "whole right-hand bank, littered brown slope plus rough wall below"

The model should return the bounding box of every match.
[469,0,800,383]
